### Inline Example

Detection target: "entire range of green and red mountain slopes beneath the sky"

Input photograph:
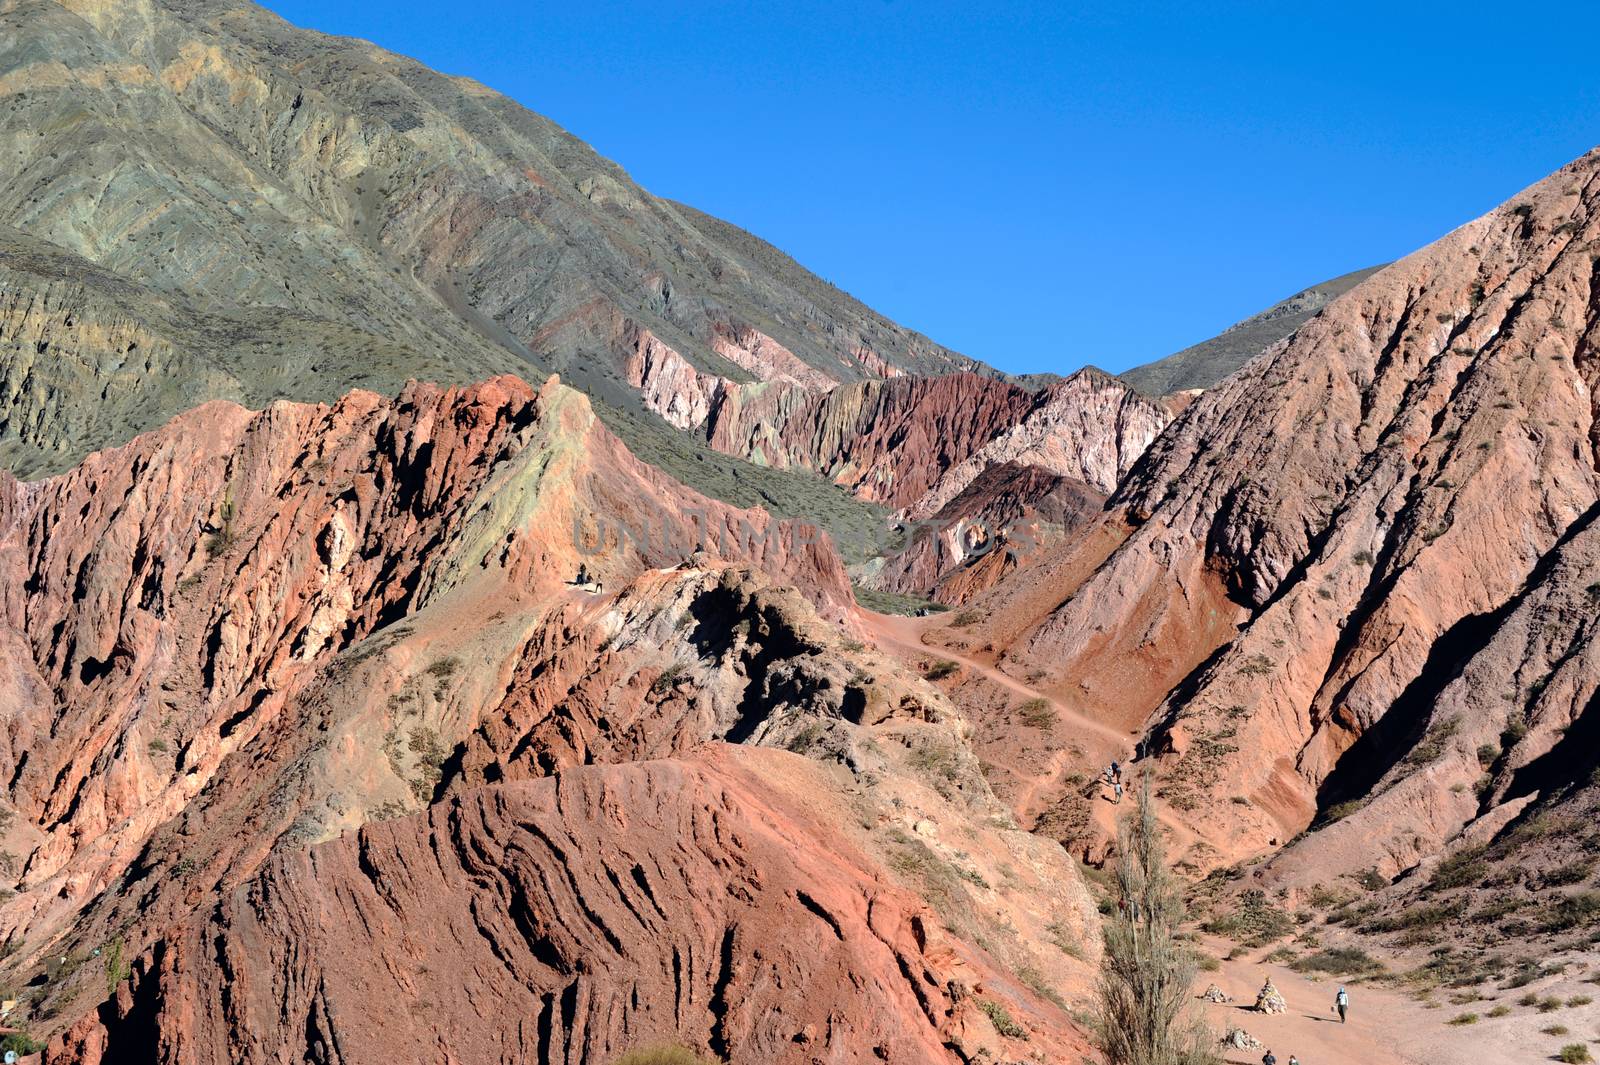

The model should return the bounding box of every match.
[0,0,1600,1065]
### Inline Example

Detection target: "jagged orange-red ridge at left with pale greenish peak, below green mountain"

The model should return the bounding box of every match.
[0,370,850,931]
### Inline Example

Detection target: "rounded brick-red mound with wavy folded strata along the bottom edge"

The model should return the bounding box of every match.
[51,748,1086,1065]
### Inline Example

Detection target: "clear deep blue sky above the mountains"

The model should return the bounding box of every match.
[269,0,1600,373]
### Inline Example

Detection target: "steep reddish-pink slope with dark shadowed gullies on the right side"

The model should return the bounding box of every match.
[962,154,1600,876]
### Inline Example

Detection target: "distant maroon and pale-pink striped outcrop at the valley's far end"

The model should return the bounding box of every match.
[706,369,1171,603]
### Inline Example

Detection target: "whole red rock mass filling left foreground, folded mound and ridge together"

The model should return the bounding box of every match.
[0,369,1094,1065]
